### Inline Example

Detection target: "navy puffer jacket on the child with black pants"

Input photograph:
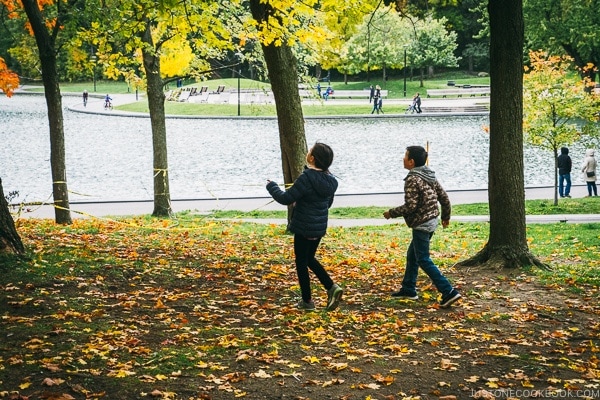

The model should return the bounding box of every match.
[267,168,338,238]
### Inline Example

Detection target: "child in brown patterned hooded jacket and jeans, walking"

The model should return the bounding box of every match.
[383,146,461,308]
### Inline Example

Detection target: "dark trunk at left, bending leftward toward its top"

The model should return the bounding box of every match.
[22,0,72,224]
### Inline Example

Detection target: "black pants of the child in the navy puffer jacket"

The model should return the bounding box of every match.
[294,234,333,302]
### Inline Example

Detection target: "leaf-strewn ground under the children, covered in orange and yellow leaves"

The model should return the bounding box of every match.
[0,218,600,400]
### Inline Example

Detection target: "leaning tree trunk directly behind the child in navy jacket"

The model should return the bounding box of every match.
[250,0,308,219]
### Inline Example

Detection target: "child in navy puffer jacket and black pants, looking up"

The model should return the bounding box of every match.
[267,142,343,311]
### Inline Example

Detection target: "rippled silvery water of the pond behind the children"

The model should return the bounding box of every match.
[0,95,575,201]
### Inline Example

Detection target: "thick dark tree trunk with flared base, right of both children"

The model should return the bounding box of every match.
[458,0,543,270]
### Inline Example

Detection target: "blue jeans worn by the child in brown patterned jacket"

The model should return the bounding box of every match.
[402,229,452,296]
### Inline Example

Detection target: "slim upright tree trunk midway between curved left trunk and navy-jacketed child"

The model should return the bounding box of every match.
[142,21,172,217]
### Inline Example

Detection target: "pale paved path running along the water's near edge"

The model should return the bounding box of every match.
[21,185,600,226]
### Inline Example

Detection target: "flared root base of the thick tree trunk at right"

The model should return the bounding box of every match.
[455,244,551,272]
